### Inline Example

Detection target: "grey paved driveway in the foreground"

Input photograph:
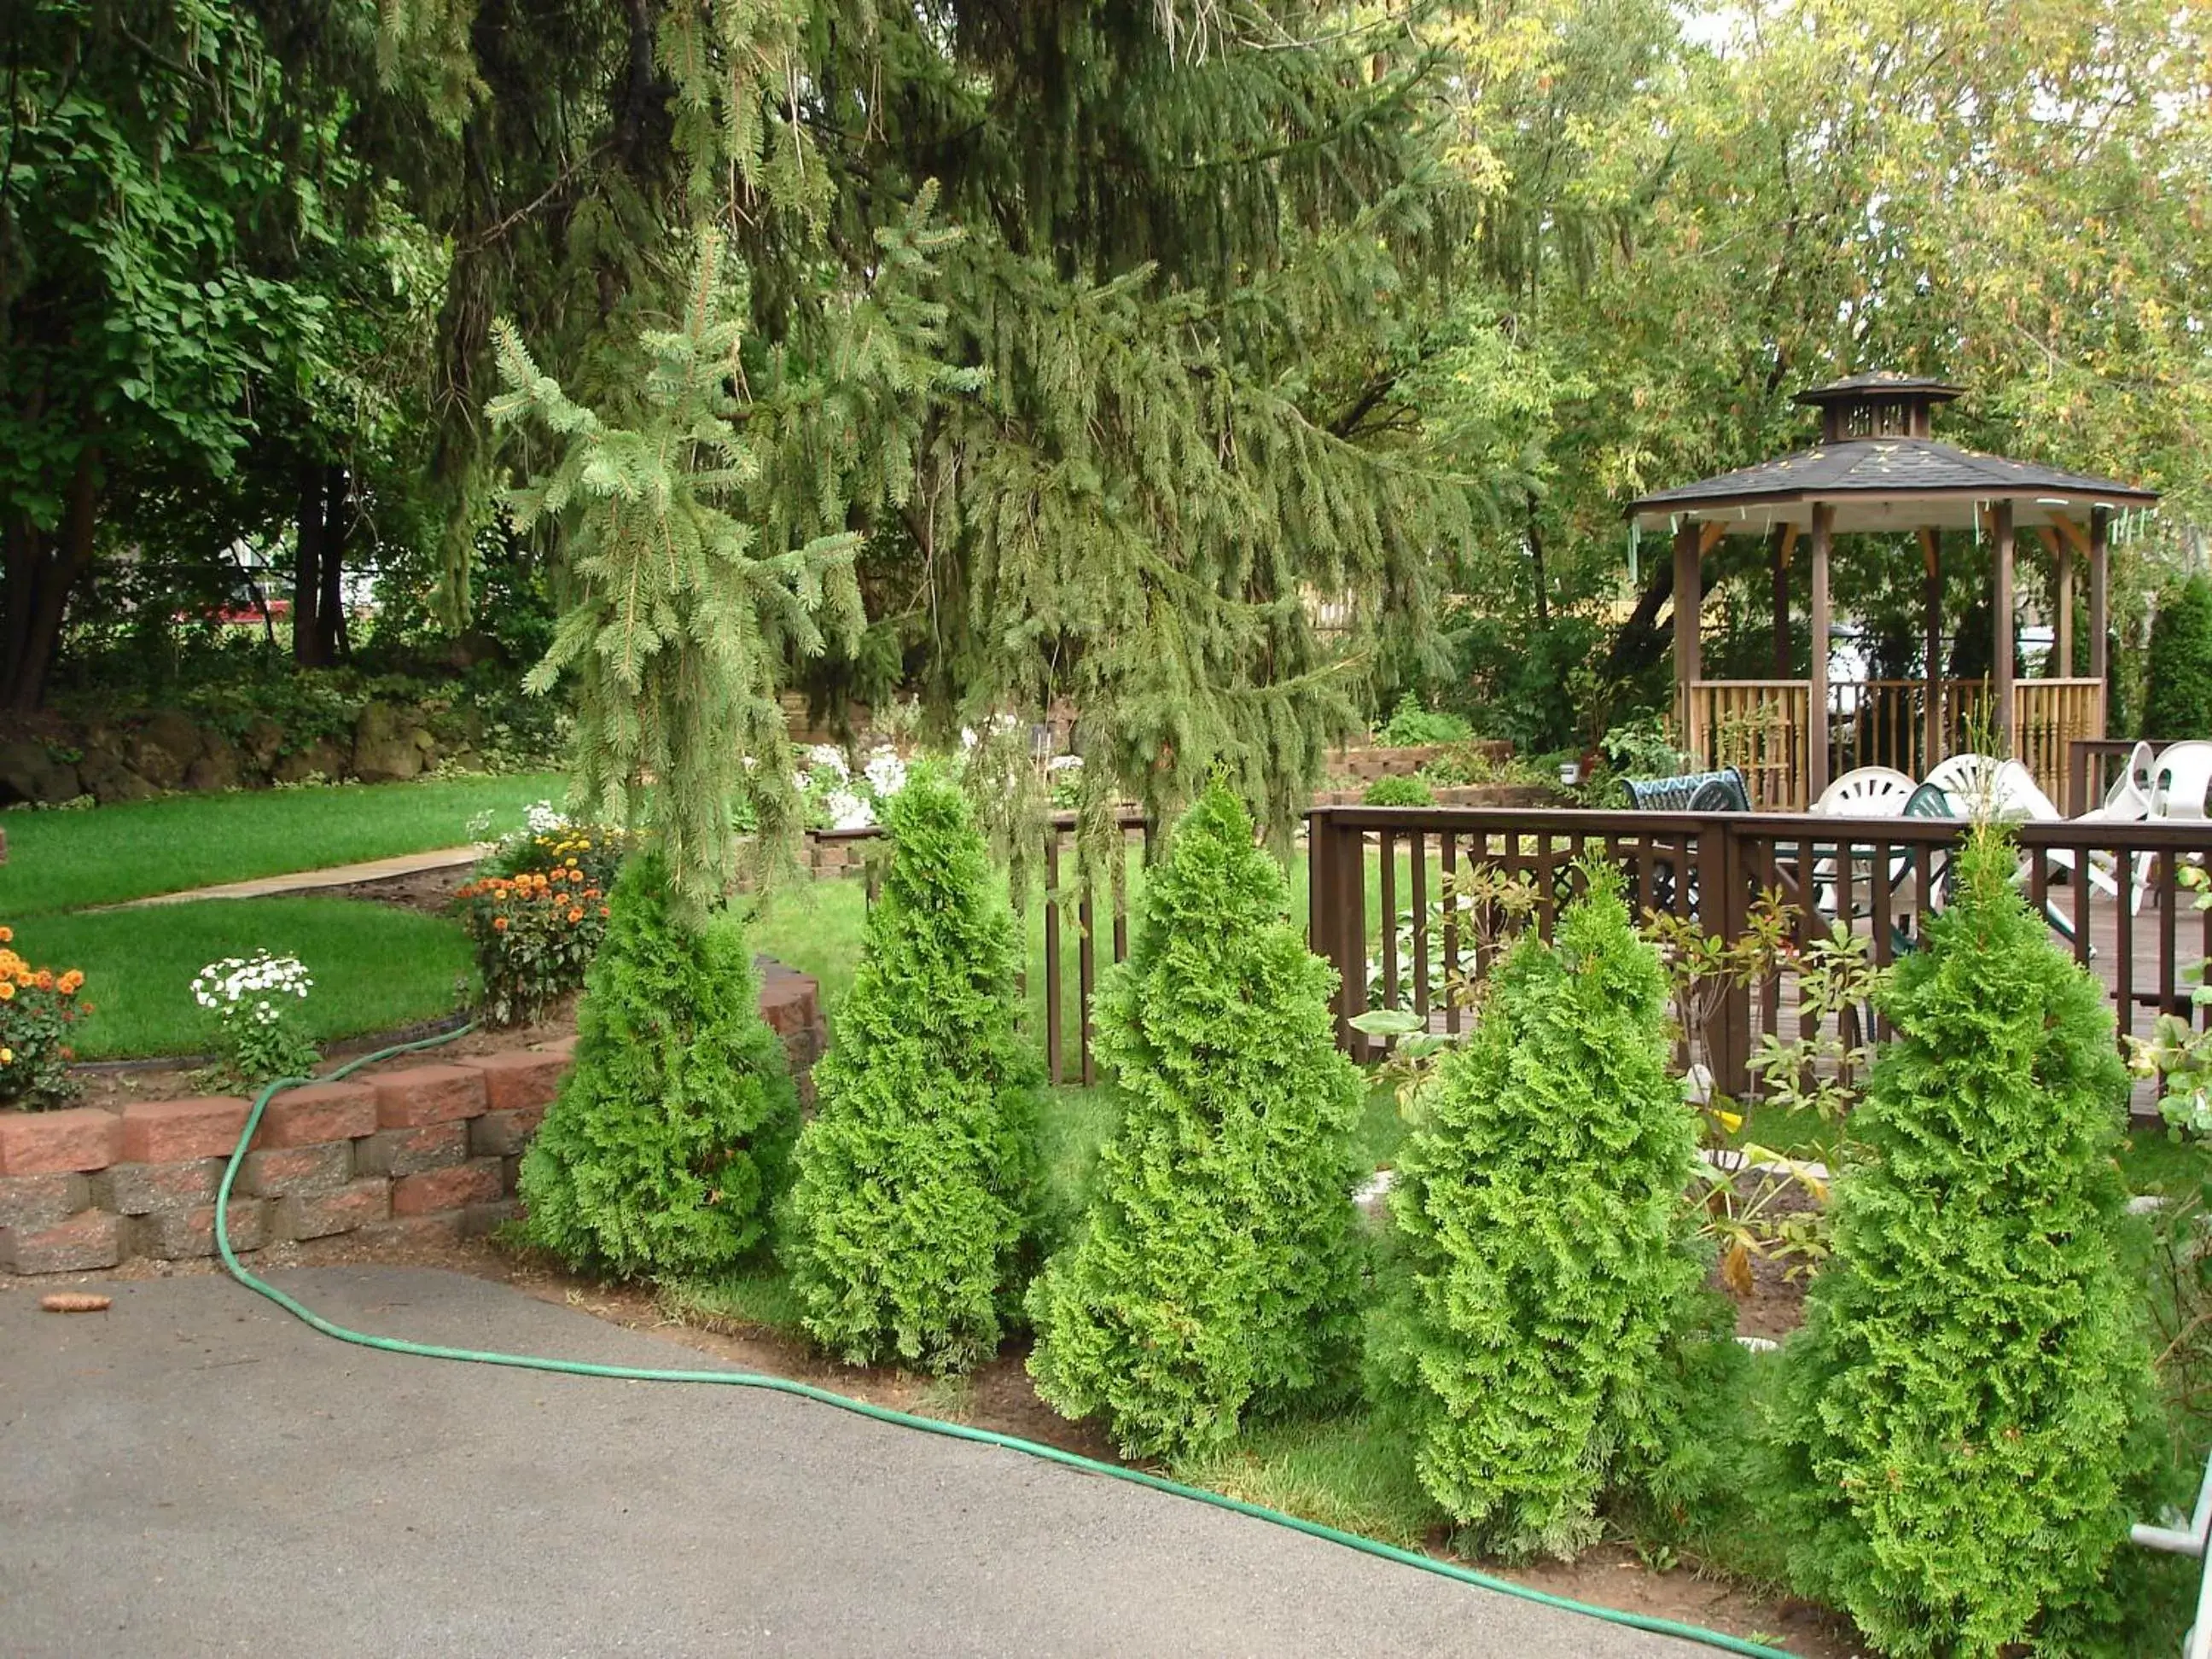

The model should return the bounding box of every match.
[0,1267,1705,1659]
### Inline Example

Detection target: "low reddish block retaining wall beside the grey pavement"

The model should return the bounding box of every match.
[0,963,825,1274]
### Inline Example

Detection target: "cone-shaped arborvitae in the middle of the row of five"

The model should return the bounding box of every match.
[1028,783,1363,1456]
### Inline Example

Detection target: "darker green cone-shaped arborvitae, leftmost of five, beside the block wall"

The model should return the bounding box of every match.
[522,854,799,1277]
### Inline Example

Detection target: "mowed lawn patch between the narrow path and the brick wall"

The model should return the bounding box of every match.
[15,898,475,1060]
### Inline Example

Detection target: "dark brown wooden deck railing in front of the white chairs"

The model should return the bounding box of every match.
[1307,807,2212,1095]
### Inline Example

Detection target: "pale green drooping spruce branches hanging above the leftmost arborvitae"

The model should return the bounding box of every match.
[486,214,964,916]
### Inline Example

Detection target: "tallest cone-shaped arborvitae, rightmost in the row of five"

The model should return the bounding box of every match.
[1772,830,2150,1655]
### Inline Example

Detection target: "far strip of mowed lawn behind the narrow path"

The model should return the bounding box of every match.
[0,772,568,918]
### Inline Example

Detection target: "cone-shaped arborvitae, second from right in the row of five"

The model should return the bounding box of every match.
[1369,870,1741,1555]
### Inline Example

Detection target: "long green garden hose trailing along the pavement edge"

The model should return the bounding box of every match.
[214,1027,1790,1659]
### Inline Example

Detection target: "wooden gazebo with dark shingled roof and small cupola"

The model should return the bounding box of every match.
[1628,374,2157,810]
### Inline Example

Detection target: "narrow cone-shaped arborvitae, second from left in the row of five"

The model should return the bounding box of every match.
[781,770,1042,1369]
